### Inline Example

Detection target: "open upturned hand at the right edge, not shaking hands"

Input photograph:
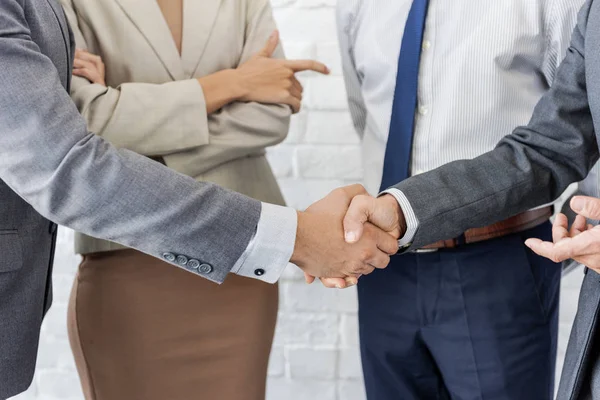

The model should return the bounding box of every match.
[525,196,600,273]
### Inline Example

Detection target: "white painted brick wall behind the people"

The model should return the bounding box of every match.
[13,0,583,400]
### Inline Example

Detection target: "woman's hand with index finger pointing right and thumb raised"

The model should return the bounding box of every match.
[235,31,329,113]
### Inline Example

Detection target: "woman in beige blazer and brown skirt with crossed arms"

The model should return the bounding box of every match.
[62,0,328,400]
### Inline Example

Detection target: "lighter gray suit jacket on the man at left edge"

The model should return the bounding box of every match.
[0,0,261,399]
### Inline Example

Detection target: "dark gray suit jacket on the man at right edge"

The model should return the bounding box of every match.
[396,0,600,400]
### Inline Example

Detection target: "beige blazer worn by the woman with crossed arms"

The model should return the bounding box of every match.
[61,0,291,254]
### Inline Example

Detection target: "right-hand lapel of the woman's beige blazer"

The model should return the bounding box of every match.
[181,0,222,79]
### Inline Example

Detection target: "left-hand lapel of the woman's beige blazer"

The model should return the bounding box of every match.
[117,0,185,80]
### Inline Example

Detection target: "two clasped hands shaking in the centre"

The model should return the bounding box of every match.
[290,185,406,289]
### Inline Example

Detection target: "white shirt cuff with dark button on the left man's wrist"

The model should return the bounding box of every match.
[231,203,298,283]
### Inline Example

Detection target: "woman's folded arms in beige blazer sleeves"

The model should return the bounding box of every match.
[63,0,324,166]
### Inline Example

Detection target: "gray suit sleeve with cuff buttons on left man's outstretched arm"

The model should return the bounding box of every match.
[0,0,261,282]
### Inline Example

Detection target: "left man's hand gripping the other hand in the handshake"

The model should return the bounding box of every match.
[290,185,398,277]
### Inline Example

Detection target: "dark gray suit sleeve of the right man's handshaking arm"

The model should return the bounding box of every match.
[395,0,598,248]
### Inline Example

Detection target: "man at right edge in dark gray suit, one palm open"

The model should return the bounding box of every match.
[344,0,600,400]
